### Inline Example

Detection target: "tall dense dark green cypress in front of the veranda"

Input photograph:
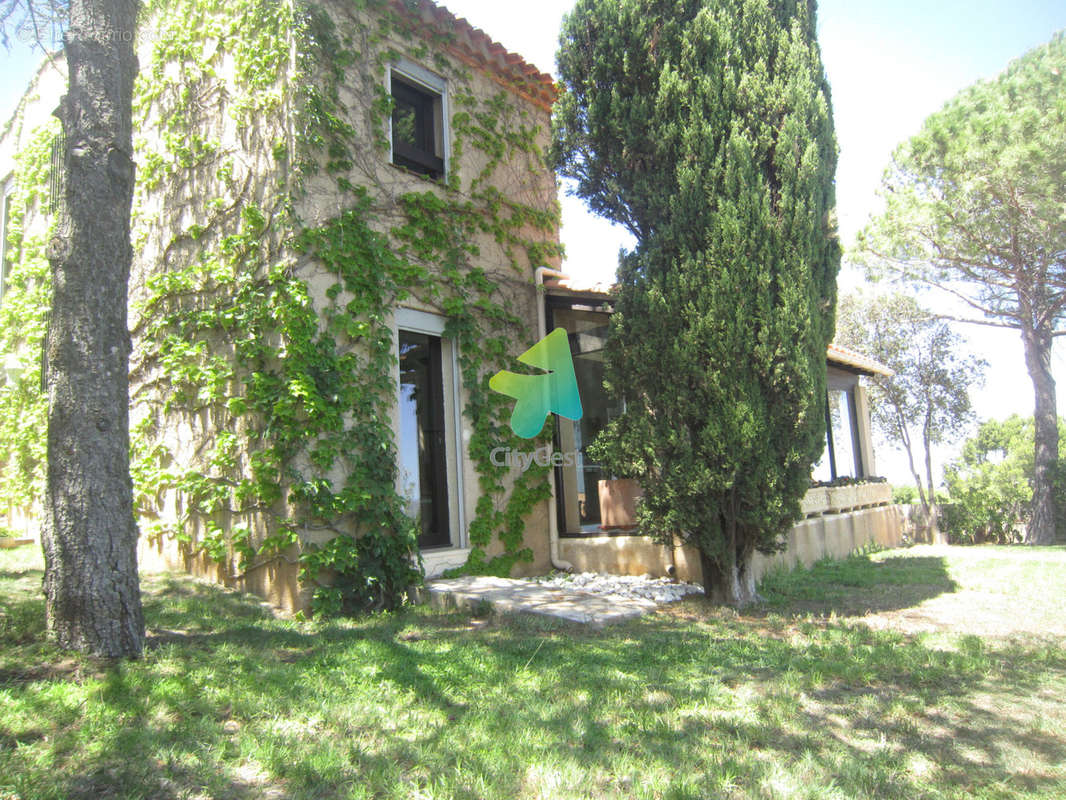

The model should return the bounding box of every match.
[554,0,839,604]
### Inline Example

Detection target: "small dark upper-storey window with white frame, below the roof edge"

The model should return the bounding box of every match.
[389,64,447,179]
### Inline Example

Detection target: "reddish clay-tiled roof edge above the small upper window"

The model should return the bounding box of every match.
[392,0,558,111]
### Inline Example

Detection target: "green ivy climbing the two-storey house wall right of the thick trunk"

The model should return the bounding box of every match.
[108,0,558,613]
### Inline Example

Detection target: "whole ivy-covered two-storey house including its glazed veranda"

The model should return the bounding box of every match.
[0,0,899,610]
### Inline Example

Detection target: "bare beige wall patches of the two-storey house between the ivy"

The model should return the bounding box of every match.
[0,0,559,610]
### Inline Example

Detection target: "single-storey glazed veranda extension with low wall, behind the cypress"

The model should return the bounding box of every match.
[546,277,901,582]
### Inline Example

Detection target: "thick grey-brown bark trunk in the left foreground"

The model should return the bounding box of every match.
[43,0,144,658]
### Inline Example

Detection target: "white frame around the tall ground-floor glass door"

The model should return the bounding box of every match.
[392,308,469,575]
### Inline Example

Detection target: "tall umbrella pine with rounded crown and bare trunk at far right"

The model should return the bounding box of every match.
[859,33,1066,542]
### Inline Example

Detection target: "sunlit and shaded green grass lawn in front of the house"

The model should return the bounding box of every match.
[0,547,1066,800]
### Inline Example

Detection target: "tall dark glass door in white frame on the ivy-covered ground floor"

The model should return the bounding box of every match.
[400,331,452,548]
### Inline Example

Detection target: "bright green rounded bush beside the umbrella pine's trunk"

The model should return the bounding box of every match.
[944,414,1066,544]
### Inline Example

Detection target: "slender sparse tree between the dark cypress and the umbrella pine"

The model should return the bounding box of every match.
[837,293,986,537]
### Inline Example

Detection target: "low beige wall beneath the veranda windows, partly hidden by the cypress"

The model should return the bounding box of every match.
[560,506,903,583]
